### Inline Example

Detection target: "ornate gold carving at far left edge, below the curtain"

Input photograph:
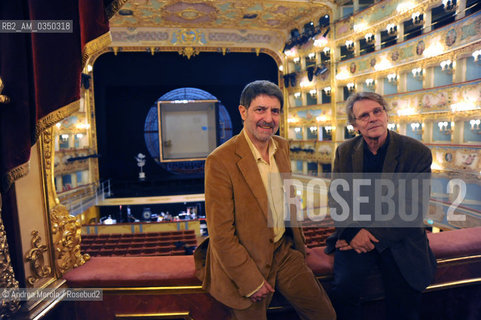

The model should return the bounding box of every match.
[0,197,20,319]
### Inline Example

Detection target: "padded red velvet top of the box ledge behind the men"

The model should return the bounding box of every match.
[65,227,481,287]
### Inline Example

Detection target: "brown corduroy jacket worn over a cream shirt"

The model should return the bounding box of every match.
[194,132,305,309]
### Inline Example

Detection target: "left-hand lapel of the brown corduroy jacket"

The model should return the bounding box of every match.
[236,132,268,219]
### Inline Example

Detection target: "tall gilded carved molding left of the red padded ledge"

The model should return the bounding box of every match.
[41,127,90,277]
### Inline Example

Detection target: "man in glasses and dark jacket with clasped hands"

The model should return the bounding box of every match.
[326,92,436,320]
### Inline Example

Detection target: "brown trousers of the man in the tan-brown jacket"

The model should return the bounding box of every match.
[232,236,336,320]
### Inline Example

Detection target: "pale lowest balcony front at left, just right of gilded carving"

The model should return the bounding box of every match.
[59,180,112,216]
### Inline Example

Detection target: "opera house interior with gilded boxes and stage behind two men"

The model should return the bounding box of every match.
[0,0,481,320]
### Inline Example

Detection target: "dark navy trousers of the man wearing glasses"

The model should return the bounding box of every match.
[331,249,421,320]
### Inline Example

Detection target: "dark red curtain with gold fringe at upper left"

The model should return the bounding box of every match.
[0,0,115,192]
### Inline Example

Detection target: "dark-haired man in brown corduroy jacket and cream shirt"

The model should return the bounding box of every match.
[194,81,336,320]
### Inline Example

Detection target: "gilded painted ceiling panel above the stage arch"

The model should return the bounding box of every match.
[110,0,332,31]
